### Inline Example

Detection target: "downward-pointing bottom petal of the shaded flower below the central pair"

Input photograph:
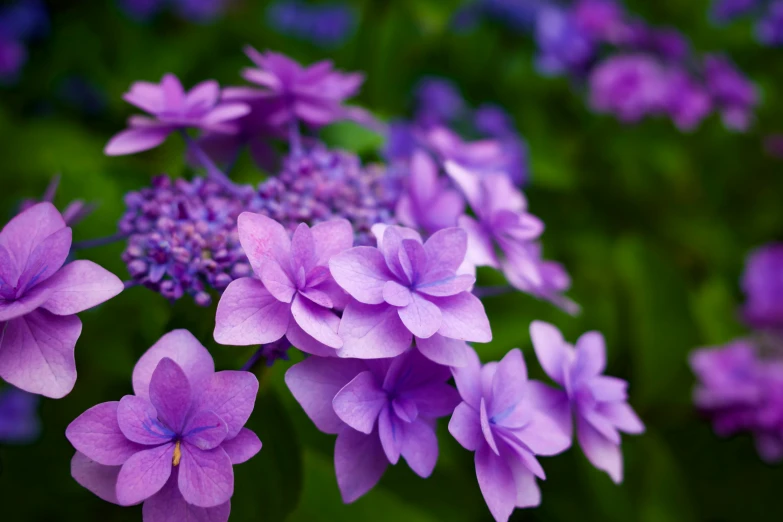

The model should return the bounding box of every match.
[334,426,389,504]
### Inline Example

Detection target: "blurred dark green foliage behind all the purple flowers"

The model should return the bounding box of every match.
[0,0,783,522]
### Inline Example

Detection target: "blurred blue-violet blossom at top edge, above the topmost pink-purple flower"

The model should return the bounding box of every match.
[266,0,357,47]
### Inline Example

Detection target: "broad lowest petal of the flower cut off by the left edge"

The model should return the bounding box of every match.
[0,309,82,399]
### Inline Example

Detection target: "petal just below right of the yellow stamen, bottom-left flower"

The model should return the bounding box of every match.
[179,444,234,508]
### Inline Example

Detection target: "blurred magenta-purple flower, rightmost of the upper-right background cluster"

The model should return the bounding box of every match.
[704,55,759,131]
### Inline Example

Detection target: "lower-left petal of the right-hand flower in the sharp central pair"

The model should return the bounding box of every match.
[338,301,413,359]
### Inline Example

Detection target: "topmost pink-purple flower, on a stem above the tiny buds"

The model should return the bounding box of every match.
[242,47,364,126]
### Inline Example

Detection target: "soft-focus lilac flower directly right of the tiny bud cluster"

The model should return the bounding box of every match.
[396,150,465,234]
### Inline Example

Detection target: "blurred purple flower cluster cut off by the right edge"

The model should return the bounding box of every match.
[690,243,783,462]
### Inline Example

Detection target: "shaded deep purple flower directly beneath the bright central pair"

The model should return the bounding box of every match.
[285,351,459,503]
